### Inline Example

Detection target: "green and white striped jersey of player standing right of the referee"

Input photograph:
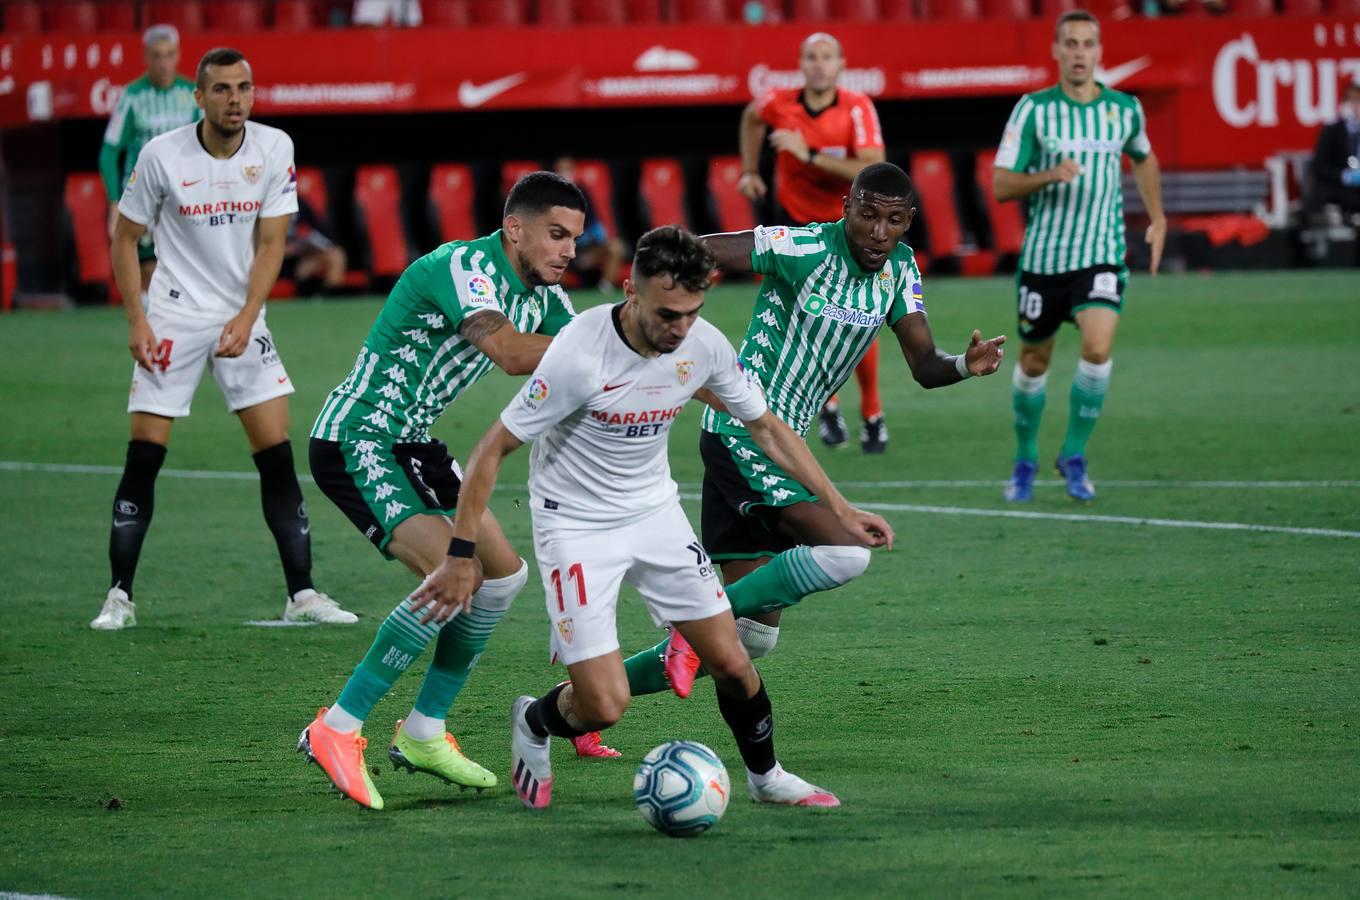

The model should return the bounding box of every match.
[996,84,1152,275]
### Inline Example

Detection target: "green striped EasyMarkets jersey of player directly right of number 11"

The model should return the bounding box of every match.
[703,219,926,435]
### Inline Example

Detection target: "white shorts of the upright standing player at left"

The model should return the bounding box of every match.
[128,306,292,419]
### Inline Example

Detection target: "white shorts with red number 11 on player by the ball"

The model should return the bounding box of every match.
[533,502,732,665]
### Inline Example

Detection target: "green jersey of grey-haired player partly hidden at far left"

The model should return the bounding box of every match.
[99,75,203,203]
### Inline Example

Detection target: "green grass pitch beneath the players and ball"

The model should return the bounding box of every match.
[0,273,1360,897]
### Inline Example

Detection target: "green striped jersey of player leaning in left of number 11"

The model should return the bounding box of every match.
[311,231,575,443]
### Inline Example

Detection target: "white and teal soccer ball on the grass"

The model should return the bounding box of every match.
[632,741,732,837]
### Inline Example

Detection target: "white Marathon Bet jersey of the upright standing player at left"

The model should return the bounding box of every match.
[118,122,298,324]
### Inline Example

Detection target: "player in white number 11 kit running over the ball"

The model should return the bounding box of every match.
[412,226,892,808]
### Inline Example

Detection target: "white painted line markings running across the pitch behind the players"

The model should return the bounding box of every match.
[0,460,1360,537]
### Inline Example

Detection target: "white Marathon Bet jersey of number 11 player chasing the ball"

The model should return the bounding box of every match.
[500,305,767,530]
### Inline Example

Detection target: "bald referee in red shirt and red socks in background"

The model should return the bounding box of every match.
[737,31,888,453]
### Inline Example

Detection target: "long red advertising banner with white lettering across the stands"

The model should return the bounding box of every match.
[0,16,1360,167]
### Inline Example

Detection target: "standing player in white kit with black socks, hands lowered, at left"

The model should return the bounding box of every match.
[90,48,358,631]
